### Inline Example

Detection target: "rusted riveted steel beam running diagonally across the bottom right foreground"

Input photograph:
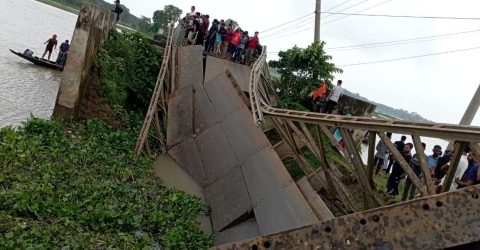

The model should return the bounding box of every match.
[212,186,480,250]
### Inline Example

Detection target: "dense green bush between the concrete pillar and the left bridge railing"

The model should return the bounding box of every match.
[95,30,162,112]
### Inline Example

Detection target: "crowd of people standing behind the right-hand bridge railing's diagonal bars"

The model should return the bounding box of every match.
[374,133,480,201]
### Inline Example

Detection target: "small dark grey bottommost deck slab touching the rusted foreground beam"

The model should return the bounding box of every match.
[213,218,260,246]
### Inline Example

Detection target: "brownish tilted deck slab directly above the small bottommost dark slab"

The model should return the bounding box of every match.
[205,167,252,232]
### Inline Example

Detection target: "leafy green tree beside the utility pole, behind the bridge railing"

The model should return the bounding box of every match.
[269,42,342,102]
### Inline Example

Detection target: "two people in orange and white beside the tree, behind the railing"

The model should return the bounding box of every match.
[308,80,343,114]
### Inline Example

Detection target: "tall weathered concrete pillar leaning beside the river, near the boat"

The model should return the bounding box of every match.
[53,5,116,120]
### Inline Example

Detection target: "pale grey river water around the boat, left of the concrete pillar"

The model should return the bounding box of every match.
[0,0,77,127]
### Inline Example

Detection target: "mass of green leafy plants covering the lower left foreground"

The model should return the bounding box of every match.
[0,119,212,249]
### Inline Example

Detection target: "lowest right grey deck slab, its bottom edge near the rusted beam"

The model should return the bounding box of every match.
[253,183,318,235]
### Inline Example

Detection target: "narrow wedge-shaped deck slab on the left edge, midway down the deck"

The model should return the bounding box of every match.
[168,138,207,187]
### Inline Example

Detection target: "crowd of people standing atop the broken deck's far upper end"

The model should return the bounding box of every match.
[180,6,262,65]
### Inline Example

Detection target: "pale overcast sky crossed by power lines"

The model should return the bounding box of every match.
[122,0,480,126]
